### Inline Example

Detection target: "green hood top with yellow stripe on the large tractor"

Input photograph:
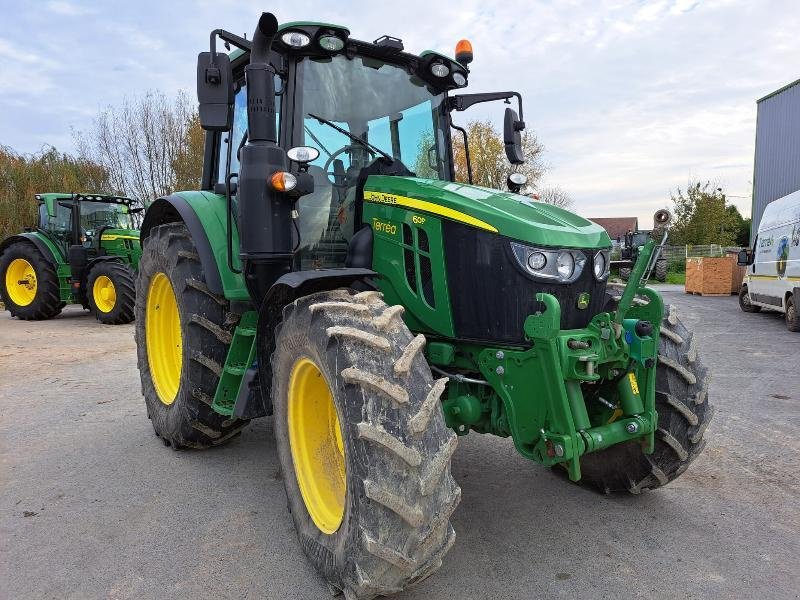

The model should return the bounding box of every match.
[364,175,611,248]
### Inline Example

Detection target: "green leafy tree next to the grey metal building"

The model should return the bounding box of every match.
[670,181,742,246]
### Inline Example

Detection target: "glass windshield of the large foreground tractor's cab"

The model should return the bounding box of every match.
[292,55,452,268]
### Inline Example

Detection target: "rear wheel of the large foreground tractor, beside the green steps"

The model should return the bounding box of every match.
[134,223,247,449]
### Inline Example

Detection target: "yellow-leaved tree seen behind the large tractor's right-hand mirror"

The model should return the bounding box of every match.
[453,119,546,189]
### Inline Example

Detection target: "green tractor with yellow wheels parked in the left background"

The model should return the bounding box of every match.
[0,194,143,325]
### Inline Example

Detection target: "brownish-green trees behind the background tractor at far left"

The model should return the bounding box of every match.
[0,146,109,240]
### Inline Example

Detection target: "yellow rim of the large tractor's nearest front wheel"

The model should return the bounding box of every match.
[288,358,347,534]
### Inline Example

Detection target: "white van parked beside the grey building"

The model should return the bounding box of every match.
[739,190,800,331]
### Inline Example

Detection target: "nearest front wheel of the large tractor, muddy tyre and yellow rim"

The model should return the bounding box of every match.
[272,290,461,600]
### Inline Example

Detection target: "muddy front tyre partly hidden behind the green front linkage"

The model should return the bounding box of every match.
[581,306,714,494]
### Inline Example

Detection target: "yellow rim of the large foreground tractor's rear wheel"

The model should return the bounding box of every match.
[144,273,183,405]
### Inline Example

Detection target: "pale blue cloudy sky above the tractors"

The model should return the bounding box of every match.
[0,0,800,228]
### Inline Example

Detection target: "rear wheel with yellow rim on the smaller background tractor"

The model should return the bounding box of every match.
[0,242,63,321]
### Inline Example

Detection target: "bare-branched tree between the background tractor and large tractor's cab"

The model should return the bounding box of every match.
[75,92,203,201]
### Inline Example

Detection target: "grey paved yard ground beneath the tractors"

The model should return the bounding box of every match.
[0,286,800,600]
